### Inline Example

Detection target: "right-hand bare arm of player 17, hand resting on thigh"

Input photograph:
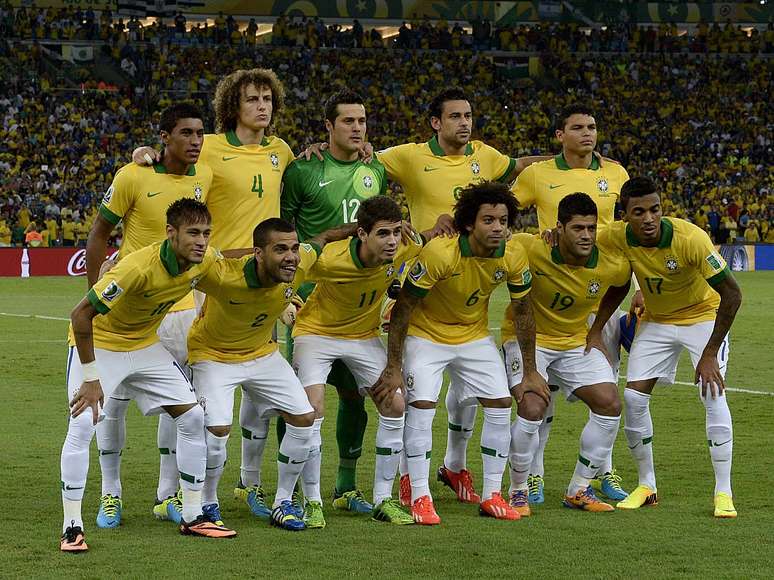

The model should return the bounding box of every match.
[694,276,742,399]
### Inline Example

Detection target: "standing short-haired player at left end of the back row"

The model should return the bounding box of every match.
[86,103,212,527]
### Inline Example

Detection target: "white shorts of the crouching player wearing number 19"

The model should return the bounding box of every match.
[503,340,616,401]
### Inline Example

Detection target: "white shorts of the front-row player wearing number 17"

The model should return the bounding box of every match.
[626,320,730,384]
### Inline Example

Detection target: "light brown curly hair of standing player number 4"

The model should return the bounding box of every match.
[213,68,285,133]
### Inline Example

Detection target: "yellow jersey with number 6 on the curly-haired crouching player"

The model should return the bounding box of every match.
[406,235,532,344]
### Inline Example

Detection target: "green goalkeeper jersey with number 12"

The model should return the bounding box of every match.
[280,150,387,241]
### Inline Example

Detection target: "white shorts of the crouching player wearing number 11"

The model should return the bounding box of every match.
[293,334,387,396]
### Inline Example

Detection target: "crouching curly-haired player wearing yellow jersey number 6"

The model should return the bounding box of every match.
[374,182,549,525]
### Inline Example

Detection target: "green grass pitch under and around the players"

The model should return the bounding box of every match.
[0,272,774,578]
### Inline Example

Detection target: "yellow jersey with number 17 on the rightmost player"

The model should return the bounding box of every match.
[610,217,731,326]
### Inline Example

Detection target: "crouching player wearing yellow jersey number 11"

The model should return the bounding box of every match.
[293,196,430,528]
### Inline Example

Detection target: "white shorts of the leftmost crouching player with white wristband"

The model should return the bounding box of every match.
[67,342,196,415]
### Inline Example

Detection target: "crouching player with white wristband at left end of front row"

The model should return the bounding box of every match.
[60,198,235,551]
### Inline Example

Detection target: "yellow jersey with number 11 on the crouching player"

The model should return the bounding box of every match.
[293,237,422,339]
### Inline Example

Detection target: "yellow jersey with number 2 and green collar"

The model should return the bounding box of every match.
[188,244,319,363]
